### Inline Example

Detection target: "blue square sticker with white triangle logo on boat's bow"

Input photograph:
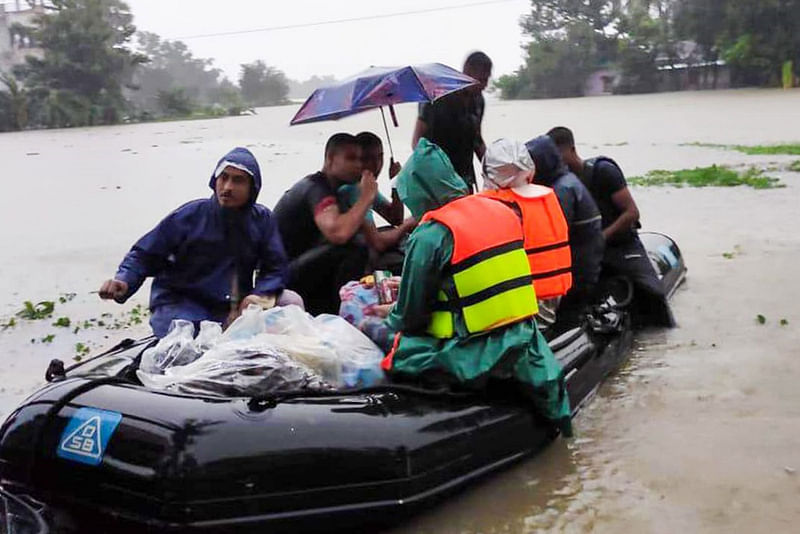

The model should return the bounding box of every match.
[56,408,122,465]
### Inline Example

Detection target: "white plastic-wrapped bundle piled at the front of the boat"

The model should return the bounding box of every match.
[137,306,383,396]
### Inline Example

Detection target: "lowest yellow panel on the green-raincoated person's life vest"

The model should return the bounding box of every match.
[462,284,539,334]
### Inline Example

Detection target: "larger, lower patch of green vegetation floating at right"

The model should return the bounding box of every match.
[628,165,786,193]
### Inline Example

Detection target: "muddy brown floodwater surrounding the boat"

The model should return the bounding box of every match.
[0,90,800,533]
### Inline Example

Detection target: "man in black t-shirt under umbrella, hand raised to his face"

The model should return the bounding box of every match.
[275,133,378,315]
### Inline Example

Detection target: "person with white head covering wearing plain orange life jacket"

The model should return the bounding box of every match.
[481,138,572,329]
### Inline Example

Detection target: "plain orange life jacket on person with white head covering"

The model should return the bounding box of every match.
[480,184,572,299]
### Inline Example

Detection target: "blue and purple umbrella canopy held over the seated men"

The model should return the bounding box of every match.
[290,63,478,125]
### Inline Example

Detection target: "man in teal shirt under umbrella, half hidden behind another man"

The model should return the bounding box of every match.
[338,132,417,274]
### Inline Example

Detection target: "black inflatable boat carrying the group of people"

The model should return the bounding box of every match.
[0,233,686,533]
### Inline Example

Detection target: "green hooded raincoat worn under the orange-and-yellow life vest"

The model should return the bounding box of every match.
[376,139,571,435]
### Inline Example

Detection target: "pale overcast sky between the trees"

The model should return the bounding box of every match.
[127,0,529,81]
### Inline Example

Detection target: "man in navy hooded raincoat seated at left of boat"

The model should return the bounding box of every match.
[99,148,303,337]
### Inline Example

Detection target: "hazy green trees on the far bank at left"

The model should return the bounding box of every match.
[0,0,289,131]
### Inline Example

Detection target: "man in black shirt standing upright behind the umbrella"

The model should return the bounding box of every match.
[411,52,492,191]
